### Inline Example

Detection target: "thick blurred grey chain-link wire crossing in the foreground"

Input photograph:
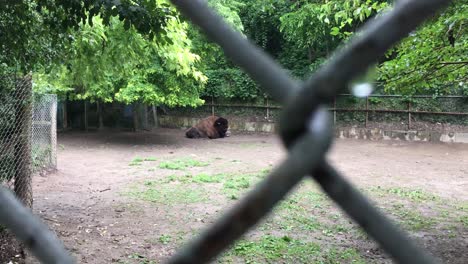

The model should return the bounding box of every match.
[0,0,449,263]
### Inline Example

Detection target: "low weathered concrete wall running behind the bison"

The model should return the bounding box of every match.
[159,116,468,143]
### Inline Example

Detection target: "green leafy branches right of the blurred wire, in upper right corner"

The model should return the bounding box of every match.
[379,0,468,95]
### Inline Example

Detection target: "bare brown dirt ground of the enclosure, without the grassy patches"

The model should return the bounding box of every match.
[17,129,468,264]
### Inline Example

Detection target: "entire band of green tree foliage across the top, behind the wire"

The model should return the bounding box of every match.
[4,0,468,111]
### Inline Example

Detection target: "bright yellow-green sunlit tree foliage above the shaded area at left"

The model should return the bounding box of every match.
[38,14,206,106]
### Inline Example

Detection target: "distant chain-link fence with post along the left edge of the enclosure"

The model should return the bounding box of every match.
[0,74,57,259]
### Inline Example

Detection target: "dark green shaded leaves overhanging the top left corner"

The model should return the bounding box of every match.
[0,0,176,73]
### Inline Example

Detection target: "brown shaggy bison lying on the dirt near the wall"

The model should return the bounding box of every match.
[185,116,228,139]
